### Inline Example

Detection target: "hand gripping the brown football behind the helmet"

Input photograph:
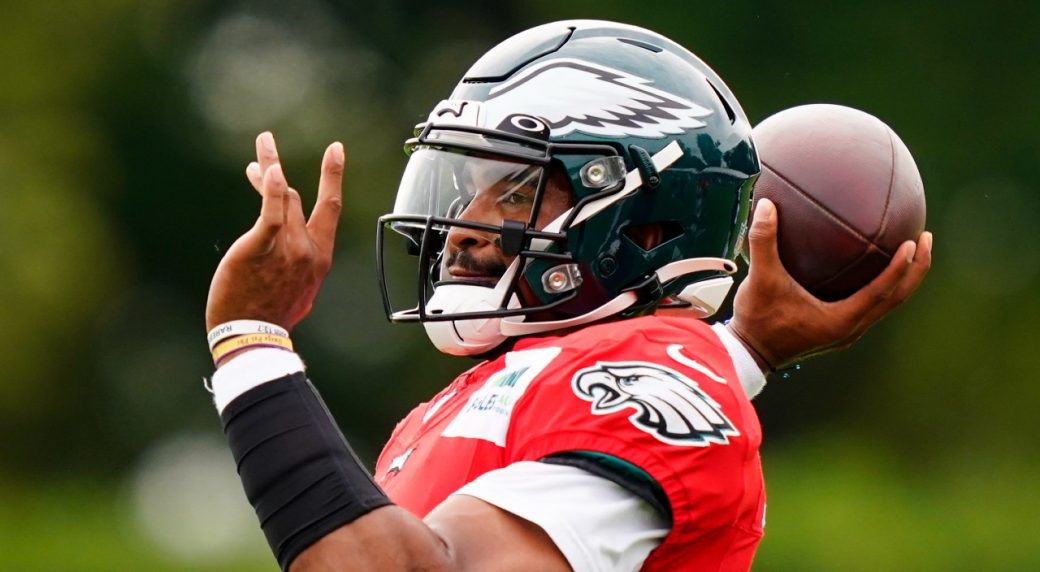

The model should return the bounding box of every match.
[728,199,932,368]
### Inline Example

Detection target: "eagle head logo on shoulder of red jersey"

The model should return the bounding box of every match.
[572,362,740,447]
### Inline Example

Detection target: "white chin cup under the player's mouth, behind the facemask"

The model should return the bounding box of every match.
[422,284,520,356]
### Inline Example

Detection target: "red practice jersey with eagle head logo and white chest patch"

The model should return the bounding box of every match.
[375,316,765,571]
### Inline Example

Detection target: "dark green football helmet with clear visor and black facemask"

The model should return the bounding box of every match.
[376,20,759,355]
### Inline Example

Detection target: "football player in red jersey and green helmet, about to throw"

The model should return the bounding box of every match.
[206,21,931,571]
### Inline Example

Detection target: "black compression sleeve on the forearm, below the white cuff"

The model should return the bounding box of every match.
[220,372,390,570]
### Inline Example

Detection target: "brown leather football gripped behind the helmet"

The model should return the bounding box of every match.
[753,104,925,301]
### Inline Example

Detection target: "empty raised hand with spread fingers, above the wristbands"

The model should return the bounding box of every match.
[206,132,345,330]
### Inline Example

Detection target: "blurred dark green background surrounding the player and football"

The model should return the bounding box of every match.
[0,0,1040,571]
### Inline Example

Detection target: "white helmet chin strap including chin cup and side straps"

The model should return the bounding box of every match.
[423,141,736,356]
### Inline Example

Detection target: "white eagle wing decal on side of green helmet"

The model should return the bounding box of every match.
[486,58,711,138]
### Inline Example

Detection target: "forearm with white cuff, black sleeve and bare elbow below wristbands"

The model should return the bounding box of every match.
[214,349,459,571]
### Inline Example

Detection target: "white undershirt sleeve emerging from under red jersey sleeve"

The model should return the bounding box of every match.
[454,462,669,572]
